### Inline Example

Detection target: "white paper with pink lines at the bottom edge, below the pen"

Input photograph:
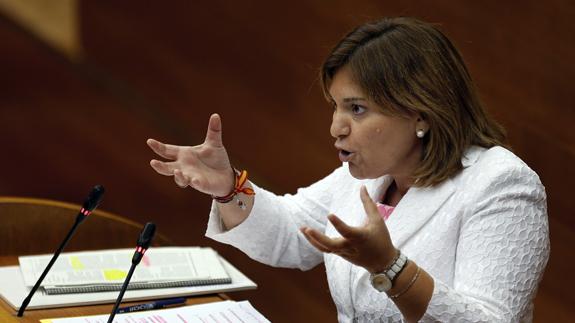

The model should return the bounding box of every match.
[40,301,270,323]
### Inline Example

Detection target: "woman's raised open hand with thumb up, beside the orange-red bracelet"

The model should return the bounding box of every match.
[150,114,235,196]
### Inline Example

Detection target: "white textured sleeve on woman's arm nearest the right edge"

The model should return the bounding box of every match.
[422,162,549,322]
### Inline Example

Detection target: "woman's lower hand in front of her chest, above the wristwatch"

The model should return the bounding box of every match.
[301,186,397,273]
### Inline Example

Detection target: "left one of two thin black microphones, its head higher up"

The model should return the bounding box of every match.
[18,185,105,317]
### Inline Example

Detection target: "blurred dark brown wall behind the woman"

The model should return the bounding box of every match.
[0,0,575,322]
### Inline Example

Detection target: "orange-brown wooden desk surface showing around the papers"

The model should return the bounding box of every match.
[0,256,229,323]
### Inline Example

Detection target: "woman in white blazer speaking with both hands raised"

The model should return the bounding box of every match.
[148,17,549,322]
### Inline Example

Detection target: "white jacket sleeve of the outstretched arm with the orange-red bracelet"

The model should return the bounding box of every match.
[206,165,351,270]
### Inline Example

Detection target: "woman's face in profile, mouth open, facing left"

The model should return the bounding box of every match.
[329,66,428,181]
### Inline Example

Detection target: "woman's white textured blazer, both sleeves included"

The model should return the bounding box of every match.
[206,147,549,322]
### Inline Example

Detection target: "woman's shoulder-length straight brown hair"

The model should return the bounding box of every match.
[320,17,505,186]
